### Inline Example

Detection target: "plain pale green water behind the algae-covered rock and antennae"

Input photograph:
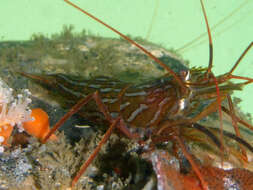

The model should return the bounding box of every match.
[0,0,253,114]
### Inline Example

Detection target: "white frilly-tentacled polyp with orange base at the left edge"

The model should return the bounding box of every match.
[0,80,32,152]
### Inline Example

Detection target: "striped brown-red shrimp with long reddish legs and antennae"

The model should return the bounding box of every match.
[22,0,253,190]
